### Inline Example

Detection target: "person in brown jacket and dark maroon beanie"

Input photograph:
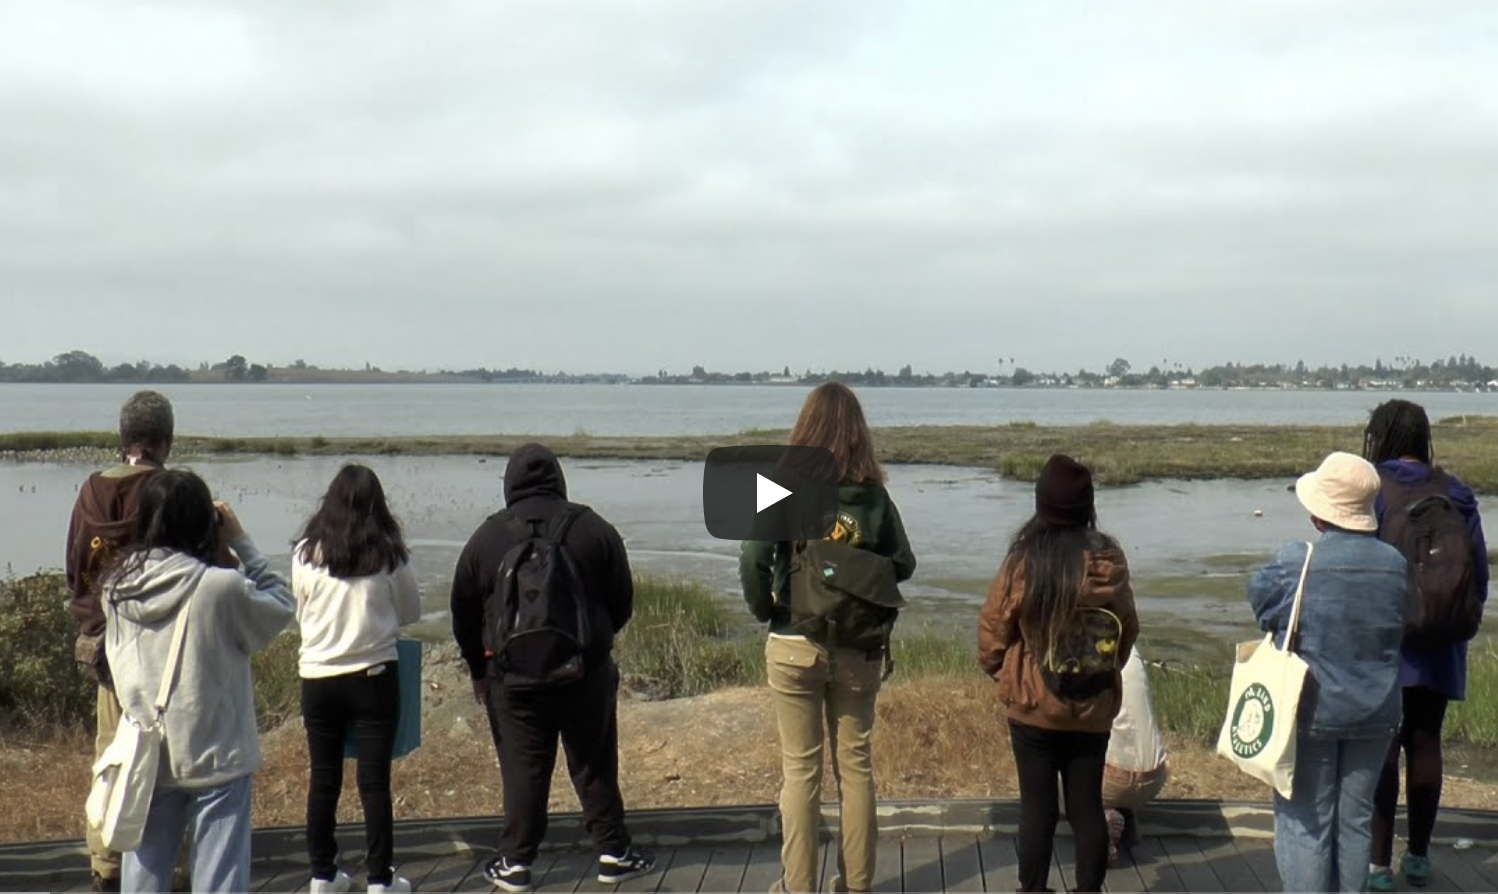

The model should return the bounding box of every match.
[978,454,1138,891]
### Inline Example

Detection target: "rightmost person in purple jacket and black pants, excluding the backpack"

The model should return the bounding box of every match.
[1363,400,1488,891]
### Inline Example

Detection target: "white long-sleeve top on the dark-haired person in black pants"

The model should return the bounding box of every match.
[291,544,421,680]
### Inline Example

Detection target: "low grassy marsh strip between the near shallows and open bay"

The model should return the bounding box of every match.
[0,416,1498,493]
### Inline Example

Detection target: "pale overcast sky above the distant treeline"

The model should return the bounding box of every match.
[0,0,1498,373]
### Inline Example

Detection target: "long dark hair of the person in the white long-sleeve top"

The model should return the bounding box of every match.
[297,463,410,578]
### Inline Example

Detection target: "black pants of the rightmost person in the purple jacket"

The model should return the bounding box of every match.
[1374,686,1449,866]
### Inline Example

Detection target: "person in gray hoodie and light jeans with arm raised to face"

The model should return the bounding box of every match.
[105,470,295,893]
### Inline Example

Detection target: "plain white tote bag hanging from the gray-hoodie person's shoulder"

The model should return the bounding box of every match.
[84,599,192,854]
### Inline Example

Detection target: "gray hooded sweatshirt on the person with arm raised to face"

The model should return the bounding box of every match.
[105,536,295,789]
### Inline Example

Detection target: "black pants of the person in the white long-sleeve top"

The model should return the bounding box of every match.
[301,662,400,885]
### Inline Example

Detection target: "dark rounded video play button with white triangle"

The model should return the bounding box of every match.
[703,445,837,541]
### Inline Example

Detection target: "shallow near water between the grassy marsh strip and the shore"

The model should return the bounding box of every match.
[0,457,1309,652]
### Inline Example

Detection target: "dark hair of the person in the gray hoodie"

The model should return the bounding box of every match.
[109,469,222,577]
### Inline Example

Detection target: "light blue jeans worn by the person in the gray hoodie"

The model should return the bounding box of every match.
[120,776,252,894]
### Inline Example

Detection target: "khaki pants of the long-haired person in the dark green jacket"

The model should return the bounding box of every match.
[764,636,884,893]
